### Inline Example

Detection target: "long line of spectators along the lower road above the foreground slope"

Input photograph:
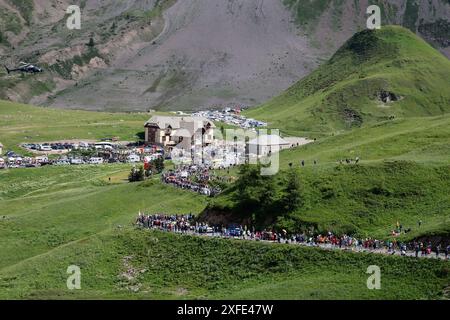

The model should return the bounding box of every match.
[136,213,450,260]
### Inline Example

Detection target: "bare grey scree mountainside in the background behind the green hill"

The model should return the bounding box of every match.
[0,0,450,111]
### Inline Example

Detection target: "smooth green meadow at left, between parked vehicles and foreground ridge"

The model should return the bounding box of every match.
[0,165,205,268]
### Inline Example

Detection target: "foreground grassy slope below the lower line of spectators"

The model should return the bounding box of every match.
[0,228,449,299]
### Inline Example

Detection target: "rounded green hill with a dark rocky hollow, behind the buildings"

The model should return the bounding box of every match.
[247,26,450,136]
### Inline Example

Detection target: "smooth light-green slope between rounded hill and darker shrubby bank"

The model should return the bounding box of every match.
[280,114,450,168]
